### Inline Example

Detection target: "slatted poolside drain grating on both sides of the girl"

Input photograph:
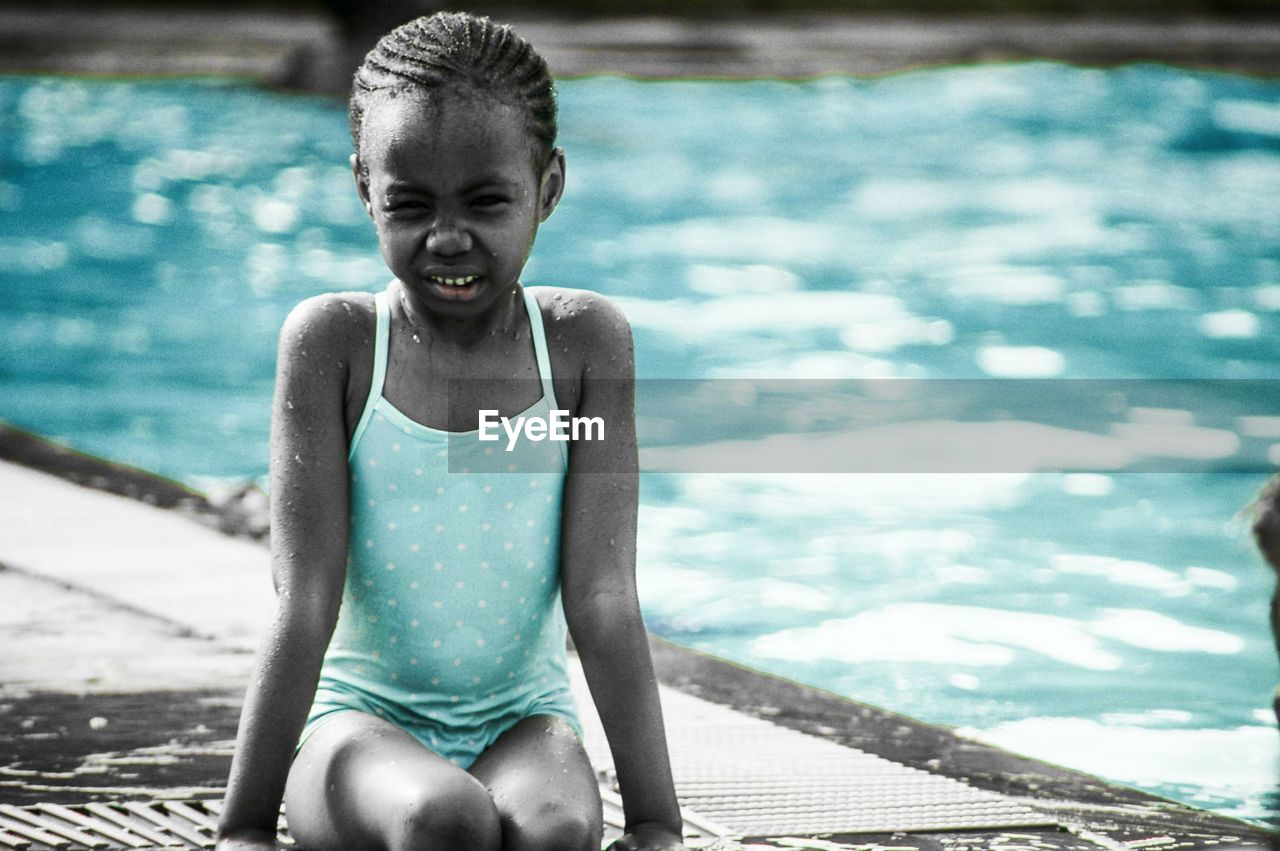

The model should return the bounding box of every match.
[0,665,1056,851]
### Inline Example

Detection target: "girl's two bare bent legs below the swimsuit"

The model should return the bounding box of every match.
[284,712,603,851]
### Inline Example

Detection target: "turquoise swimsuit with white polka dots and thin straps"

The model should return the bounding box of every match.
[298,281,581,768]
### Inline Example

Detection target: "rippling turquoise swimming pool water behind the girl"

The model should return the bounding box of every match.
[0,64,1280,824]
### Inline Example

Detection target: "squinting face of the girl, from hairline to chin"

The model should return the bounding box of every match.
[352,92,564,319]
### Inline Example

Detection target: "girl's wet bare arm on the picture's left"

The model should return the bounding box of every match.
[218,296,355,851]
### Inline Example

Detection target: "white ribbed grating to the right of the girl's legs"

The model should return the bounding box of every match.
[576,681,1056,837]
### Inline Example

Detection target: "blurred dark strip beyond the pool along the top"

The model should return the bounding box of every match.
[0,0,1280,83]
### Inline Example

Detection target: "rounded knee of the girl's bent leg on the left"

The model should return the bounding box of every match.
[389,775,502,851]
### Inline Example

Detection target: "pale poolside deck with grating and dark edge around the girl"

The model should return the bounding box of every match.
[0,427,1274,851]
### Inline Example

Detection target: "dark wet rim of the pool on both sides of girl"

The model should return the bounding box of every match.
[0,424,1280,847]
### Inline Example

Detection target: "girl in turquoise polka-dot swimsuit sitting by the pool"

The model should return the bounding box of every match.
[218,14,682,851]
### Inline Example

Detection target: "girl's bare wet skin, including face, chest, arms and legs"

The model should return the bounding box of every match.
[218,87,684,851]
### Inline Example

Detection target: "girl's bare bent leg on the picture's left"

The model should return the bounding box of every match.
[284,710,502,851]
